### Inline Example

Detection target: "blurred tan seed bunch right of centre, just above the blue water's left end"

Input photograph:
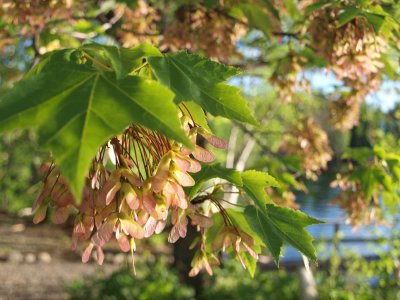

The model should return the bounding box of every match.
[281,118,332,180]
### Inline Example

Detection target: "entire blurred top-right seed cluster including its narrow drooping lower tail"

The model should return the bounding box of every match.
[307,6,387,130]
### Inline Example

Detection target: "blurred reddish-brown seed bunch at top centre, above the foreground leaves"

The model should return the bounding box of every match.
[163,5,245,61]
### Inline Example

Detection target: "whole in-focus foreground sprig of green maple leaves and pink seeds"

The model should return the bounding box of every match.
[0,44,319,276]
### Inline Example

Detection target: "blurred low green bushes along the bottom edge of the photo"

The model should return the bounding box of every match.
[66,231,400,300]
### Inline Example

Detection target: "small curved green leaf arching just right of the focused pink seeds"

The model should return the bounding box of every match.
[188,164,242,198]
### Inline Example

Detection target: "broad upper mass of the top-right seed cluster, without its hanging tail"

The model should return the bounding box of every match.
[308,7,386,81]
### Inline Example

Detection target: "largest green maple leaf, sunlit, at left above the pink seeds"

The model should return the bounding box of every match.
[0,50,191,201]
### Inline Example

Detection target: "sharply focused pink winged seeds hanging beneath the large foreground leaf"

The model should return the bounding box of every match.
[33,105,257,275]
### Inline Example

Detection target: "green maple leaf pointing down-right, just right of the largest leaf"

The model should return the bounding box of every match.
[149,52,257,125]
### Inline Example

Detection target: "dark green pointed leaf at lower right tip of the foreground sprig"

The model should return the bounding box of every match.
[245,204,323,265]
